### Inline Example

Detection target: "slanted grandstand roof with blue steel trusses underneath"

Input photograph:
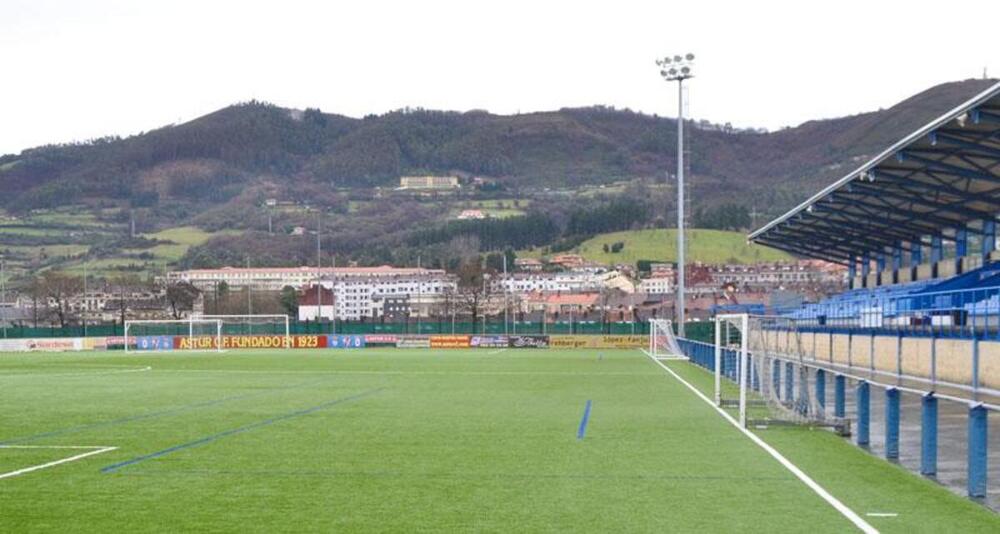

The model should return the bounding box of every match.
[749,83,1000,264]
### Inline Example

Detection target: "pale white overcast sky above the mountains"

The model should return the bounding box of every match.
[0,0,1000,154]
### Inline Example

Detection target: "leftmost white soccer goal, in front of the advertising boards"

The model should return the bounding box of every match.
[125,318,222,352]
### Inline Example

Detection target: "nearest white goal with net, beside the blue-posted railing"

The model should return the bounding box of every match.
[715,314,846,429]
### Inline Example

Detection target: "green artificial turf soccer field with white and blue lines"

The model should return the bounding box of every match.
[0,349,1000,532]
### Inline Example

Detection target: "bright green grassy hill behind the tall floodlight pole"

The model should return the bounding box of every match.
[518,229,792,265]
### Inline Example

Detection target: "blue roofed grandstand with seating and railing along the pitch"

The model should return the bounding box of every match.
[680,79,1000,508]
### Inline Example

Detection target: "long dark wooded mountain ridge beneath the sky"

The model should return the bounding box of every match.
[0,80,992,284]
